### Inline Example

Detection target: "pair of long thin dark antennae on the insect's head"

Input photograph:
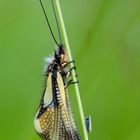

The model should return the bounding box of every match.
[39,0,62,47]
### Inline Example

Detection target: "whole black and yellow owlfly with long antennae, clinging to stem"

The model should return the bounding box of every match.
[34,0,81,140]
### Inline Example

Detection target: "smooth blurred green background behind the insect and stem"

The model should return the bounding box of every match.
[0,0,140,140]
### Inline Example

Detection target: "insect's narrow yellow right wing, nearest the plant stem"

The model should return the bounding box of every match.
[57,72,81,140]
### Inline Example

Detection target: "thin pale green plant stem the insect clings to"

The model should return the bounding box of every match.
[55,0,88,140]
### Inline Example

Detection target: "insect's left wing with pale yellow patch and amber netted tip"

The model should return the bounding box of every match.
[34,73,56,139]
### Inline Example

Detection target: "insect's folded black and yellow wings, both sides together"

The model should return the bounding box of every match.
[34,71,80,140]
